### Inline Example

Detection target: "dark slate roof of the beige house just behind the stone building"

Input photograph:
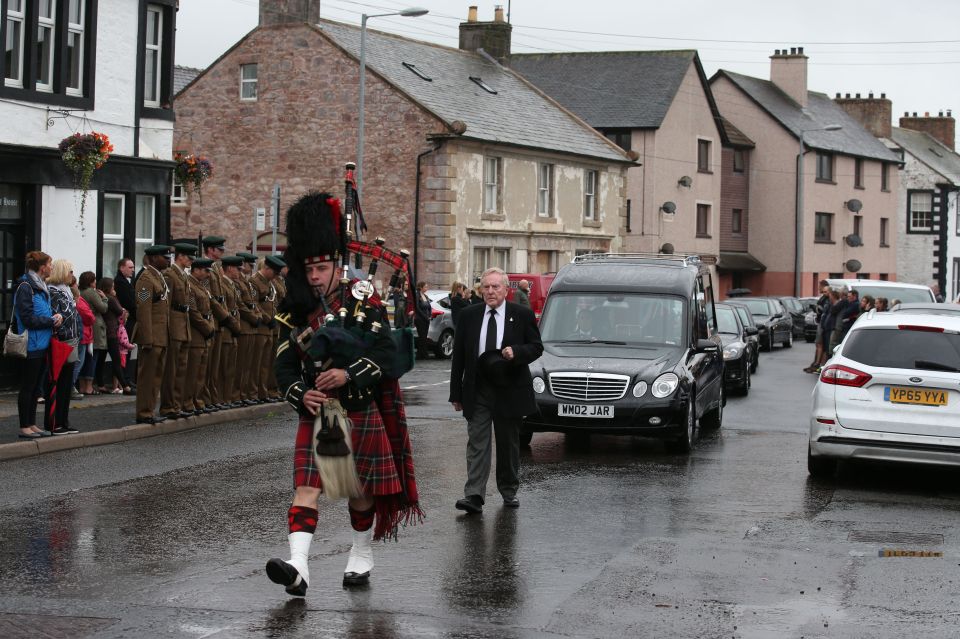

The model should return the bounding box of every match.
[510,50,697,129]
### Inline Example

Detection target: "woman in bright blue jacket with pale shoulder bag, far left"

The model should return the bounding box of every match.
[10,251,63,439]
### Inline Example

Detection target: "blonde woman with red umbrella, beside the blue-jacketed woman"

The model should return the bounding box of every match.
[44,260,83,435]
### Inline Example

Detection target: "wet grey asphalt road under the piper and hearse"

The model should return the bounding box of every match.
[0,344,960,639]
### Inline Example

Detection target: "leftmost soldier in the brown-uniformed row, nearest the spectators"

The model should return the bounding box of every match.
[134,244,172,424]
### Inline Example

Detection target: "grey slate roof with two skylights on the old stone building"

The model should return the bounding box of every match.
[314,20,630,162]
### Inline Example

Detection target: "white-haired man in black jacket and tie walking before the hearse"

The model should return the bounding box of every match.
[450,268,543,513]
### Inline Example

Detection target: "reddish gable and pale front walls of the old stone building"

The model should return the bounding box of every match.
[171,24,625,288]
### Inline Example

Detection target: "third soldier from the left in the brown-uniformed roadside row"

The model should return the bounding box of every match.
[184,257,216,415]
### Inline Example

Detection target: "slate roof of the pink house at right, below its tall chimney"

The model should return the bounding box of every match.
[711,70,900,162]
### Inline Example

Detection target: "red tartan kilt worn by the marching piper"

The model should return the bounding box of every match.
[293,379,417,504]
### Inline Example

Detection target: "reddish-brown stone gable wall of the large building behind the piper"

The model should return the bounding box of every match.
[171,25,449,278]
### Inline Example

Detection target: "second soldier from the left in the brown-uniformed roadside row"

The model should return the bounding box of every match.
[160,244,197,419]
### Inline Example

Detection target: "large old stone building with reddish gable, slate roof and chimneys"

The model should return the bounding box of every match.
[172,0,634,286]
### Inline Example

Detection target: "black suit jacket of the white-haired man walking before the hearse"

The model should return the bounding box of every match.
[450,302,543,419]
